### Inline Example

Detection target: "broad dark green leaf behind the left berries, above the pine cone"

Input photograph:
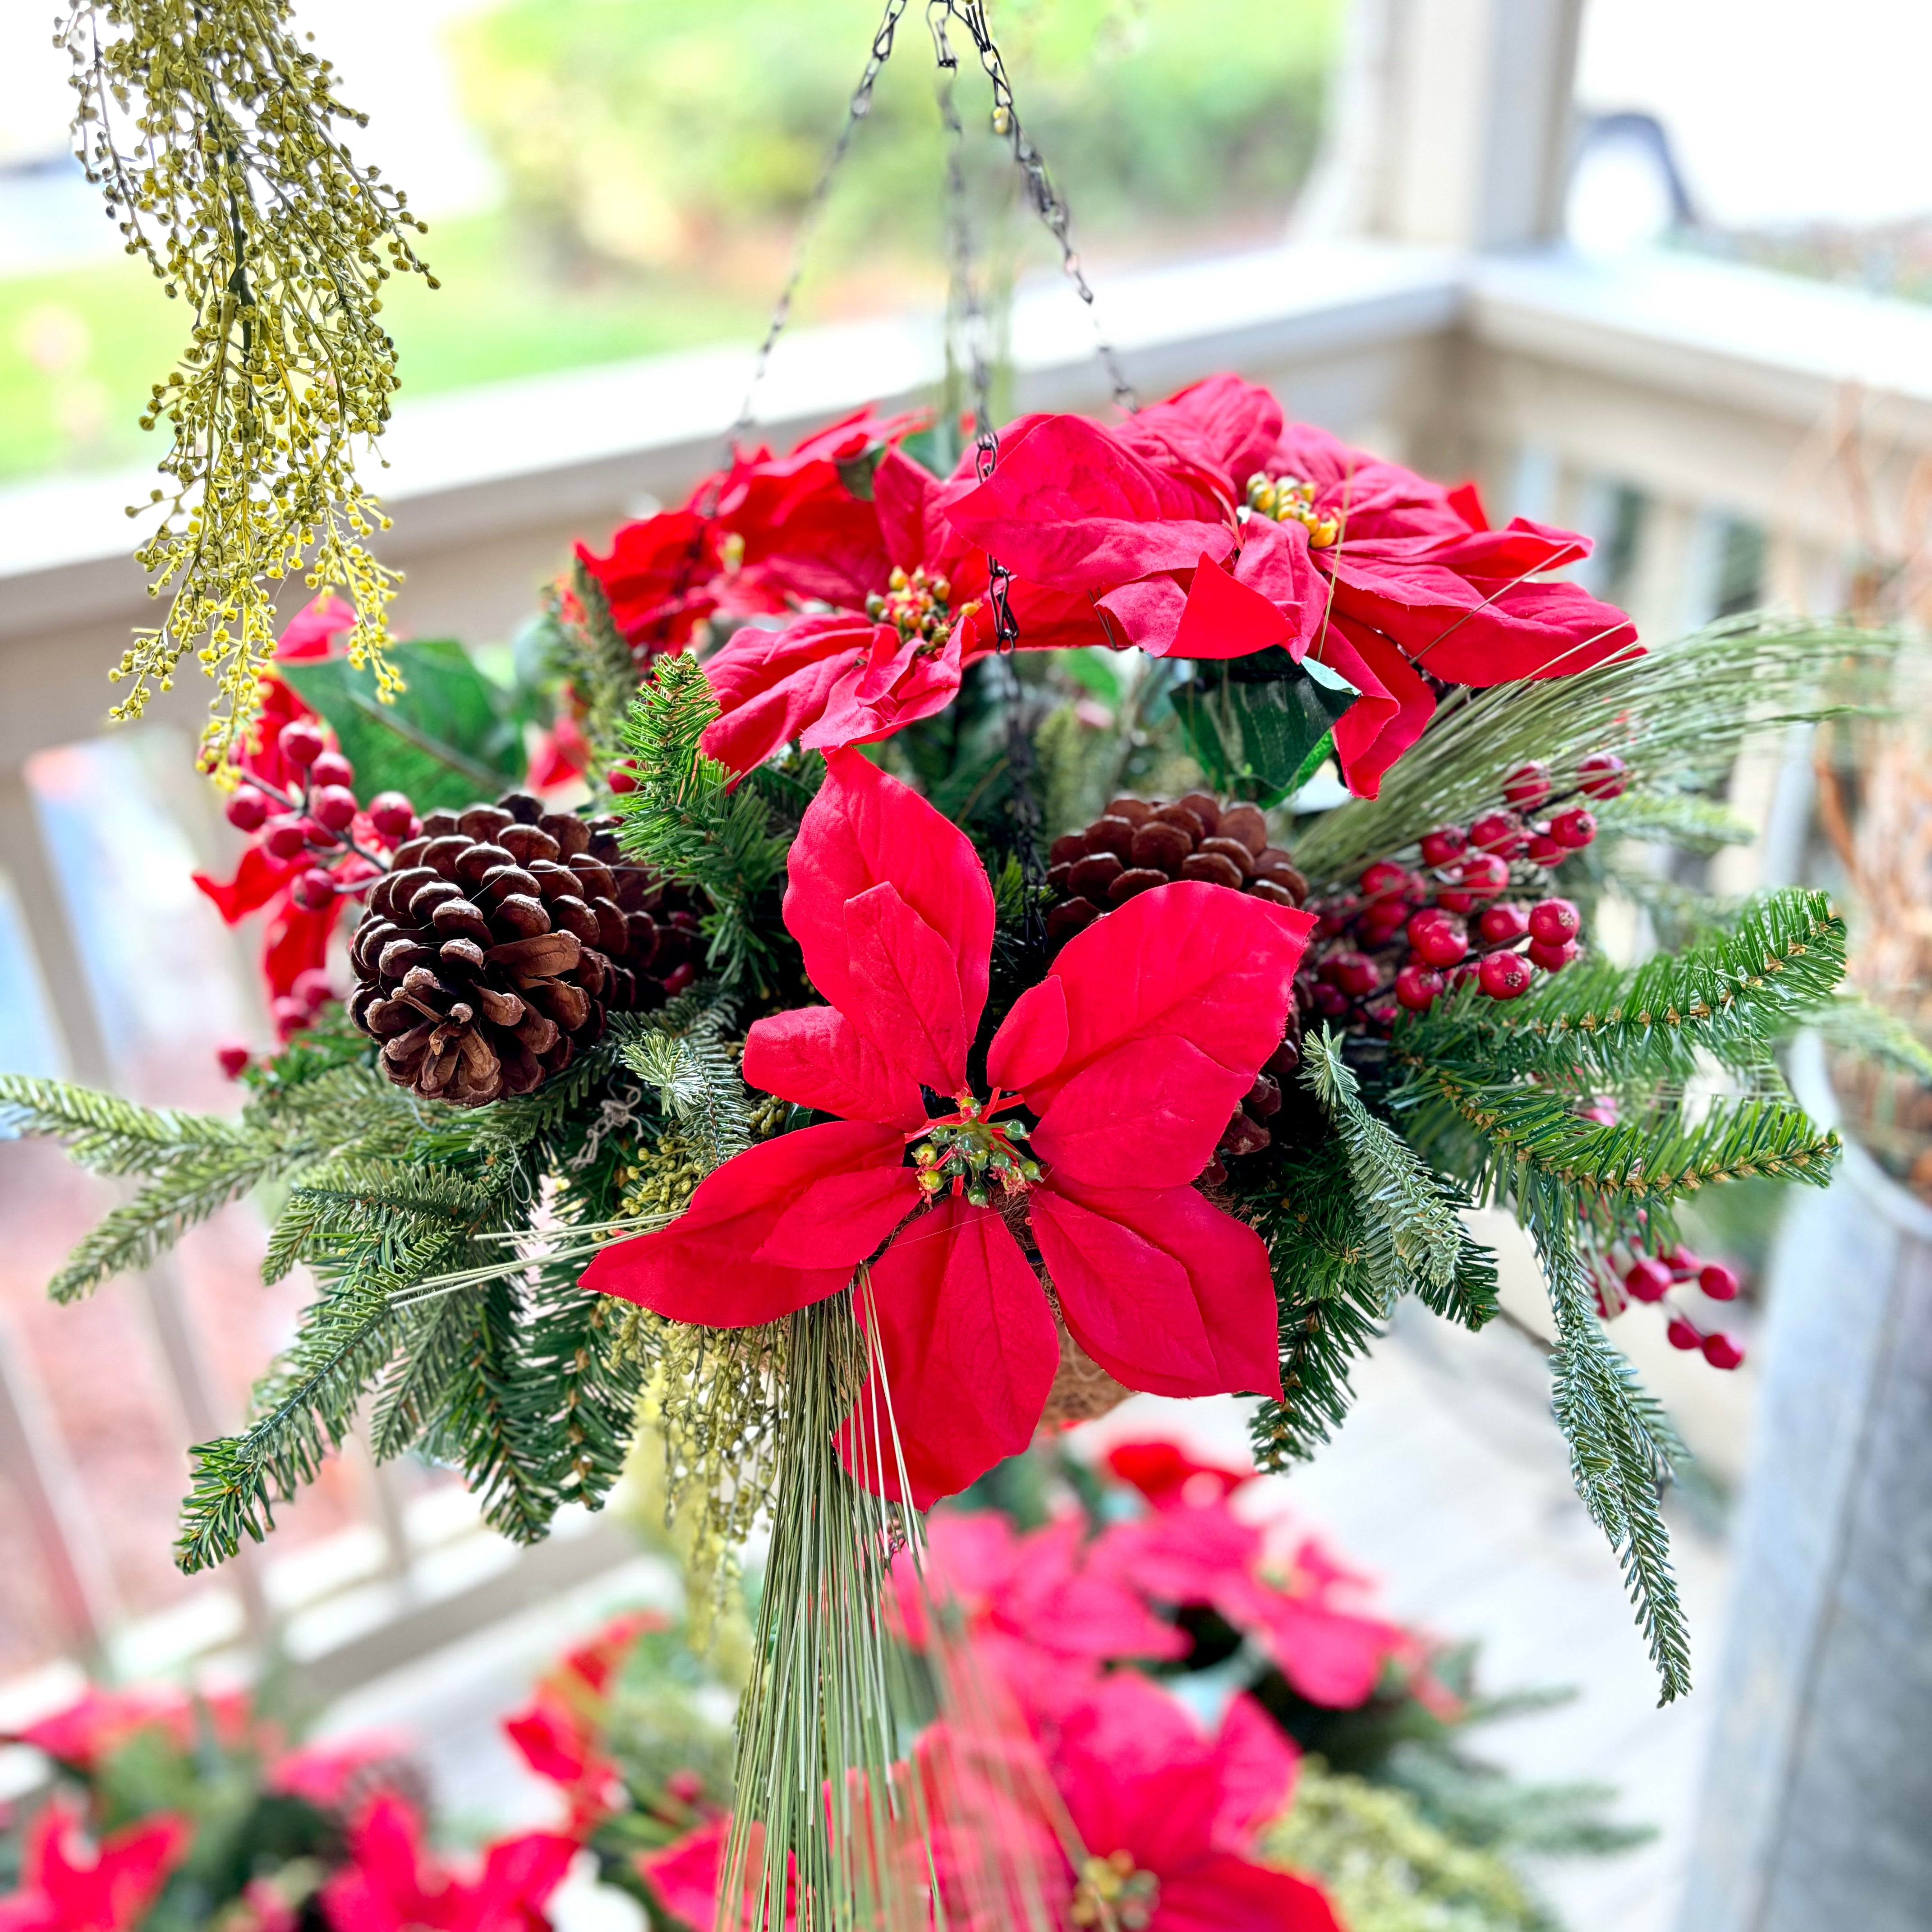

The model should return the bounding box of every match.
[276,638,524,811]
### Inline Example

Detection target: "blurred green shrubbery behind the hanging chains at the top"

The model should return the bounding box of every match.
[444,0,1341,274]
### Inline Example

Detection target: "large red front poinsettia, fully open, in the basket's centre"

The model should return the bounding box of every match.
[584,751,1312,1507]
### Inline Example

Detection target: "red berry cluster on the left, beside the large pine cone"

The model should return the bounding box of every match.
[220,719,421,1043]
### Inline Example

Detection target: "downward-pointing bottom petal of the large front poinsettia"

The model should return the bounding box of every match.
[838,1194,1061,1509]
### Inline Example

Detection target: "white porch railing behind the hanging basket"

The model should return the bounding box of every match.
[0,230,1932,1723]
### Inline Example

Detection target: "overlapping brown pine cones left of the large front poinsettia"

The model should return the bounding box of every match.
[350,792,698,1107]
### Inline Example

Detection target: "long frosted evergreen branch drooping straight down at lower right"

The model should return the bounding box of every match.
[1521,1182,1691,1704]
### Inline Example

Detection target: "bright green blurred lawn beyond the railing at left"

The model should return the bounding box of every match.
[0,215,763,483]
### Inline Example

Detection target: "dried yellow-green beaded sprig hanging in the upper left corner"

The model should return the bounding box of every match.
[56,0,437,775]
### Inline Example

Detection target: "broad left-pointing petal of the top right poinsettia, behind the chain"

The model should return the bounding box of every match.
[948,415,1234,591]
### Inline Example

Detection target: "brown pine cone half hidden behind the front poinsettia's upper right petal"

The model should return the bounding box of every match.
[1047,792,1308,945]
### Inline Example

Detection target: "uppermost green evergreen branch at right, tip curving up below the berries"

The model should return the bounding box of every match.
[1399,889,1845,1082]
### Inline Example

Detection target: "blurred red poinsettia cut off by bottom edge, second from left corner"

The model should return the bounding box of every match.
[321,1795,578,1932]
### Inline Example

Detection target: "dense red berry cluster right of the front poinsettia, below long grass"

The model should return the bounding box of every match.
[1297,751,1625,1034]
